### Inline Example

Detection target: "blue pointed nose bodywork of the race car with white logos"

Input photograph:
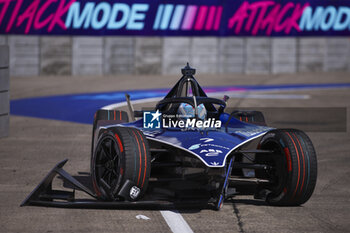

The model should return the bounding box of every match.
[107,113,273,167]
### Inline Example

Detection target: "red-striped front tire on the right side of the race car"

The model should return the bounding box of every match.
[256,129,317,206]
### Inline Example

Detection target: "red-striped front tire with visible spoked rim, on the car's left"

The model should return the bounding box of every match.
[91,127,151,201]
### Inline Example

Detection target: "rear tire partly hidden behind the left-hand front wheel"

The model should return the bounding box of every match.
[91,109,129,156]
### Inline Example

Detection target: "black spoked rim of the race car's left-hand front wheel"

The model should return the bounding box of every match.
[94,135,121,199]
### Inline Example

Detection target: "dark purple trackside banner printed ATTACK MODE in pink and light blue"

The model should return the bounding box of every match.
[0,0,350,36]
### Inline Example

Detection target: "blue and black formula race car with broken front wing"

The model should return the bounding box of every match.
[22,64,317,209]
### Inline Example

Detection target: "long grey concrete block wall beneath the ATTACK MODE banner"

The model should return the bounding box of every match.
[0,35,350,76]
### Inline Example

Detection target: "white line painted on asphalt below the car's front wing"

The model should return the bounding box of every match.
[160,210,193,233]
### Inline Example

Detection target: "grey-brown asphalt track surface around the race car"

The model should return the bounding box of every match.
[0,73,350,233]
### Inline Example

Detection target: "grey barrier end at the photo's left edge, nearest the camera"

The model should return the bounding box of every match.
[0,45,10,137]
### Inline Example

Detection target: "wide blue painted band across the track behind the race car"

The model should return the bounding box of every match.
[10,83,350,124]
